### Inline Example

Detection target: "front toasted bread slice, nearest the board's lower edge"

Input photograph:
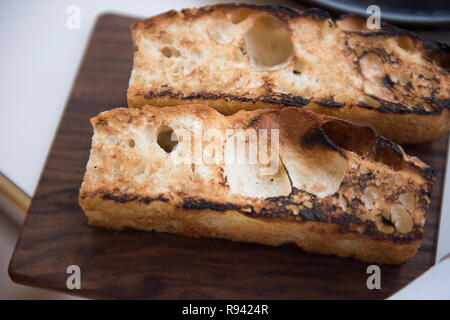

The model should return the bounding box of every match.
[79,105,434,264]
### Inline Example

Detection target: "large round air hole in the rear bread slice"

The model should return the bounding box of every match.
[244,16,294,71]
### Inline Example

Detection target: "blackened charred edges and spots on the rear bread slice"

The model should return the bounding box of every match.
[138,4,450,115]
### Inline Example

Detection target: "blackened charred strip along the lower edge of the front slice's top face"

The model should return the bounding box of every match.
[92,186,430,243]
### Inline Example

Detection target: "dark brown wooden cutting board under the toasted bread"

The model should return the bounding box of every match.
[9,14,448,299]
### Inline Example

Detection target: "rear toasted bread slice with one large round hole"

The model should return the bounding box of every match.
[128,5,450,143]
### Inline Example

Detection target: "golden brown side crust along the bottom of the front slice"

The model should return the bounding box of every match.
[83,196,421,264]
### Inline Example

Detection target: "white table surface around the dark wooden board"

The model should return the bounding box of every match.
[0,0,450,300]
